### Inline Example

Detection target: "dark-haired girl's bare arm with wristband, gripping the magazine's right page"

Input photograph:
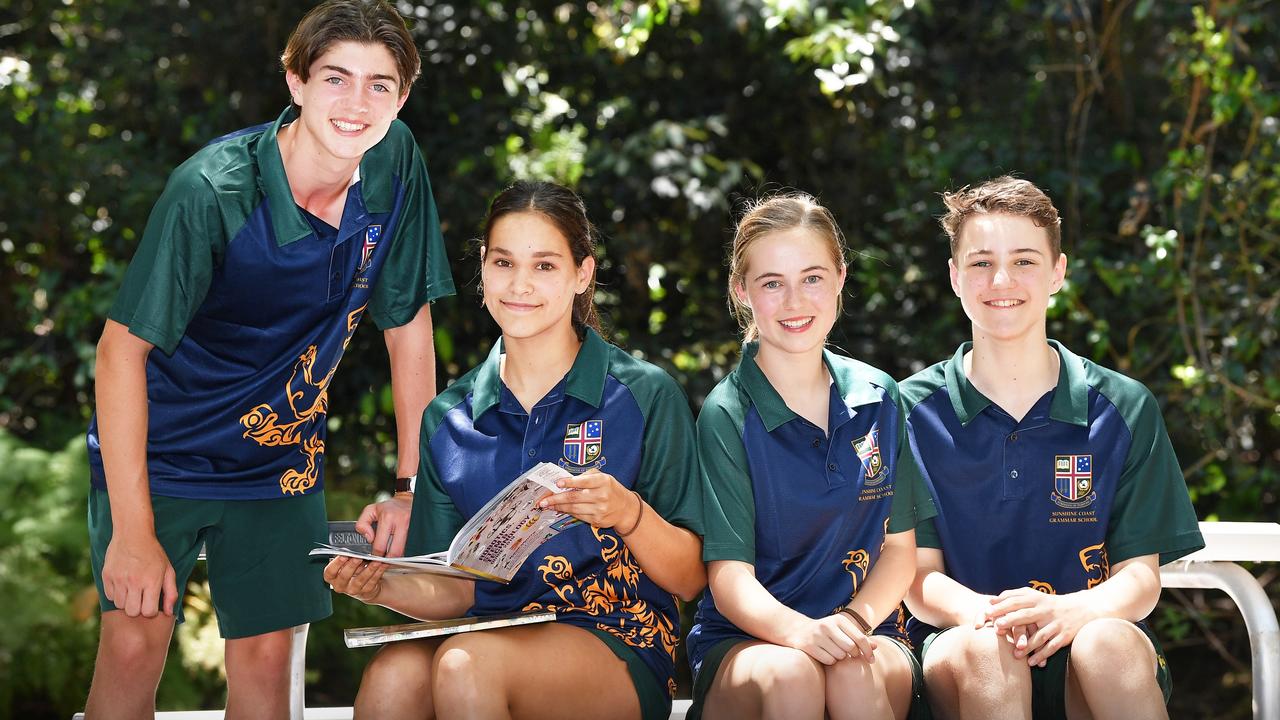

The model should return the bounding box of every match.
[541,470,707,602]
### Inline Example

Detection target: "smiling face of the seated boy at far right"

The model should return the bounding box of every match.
[947,213,1066,342]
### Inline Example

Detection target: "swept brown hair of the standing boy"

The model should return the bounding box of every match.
[280,0,421,95]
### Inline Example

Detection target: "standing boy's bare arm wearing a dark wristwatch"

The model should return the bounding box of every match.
[356,305,435,557]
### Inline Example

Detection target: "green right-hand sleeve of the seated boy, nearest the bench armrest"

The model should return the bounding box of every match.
[1107,387,1204,565]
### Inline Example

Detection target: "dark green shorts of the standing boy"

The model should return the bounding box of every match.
[88,489,333,638]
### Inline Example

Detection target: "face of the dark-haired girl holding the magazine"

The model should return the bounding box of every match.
[480,211,595,340]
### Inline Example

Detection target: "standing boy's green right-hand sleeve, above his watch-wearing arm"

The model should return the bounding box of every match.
[370,131,454,329]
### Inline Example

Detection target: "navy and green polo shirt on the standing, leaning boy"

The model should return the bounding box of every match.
[88,109,453,500]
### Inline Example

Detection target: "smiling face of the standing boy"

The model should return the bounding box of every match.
[285,41,408,160]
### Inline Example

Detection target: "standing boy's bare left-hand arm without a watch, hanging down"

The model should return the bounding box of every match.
[95,320,178,618]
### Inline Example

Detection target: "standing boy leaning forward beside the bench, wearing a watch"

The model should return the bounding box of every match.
[80,0,453,720]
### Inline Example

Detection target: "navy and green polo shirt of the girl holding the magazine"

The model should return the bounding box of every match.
[406,329,701,693]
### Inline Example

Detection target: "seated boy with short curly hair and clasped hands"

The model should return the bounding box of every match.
[901,177,1204,720]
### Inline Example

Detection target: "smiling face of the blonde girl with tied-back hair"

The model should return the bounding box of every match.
[733,227,845,355]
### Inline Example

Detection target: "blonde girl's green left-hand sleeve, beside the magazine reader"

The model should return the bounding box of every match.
[698,392,755,565]
